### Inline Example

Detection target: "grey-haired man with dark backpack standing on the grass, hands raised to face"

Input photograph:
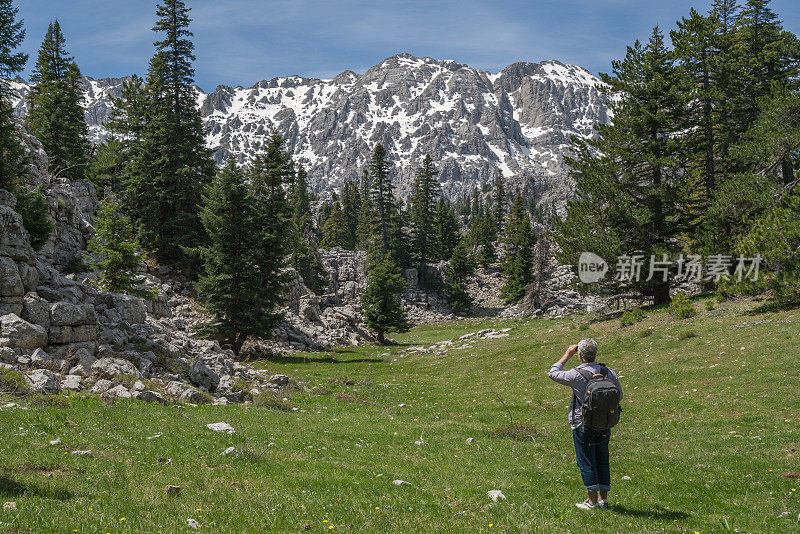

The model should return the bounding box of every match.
[548,339,622,510]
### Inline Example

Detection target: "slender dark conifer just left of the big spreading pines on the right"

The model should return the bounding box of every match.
[500,195,536,302]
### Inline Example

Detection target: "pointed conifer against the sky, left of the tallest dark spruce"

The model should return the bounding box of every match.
[28,21,90,180]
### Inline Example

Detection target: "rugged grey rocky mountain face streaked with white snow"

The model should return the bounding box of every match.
[6,54,609,204]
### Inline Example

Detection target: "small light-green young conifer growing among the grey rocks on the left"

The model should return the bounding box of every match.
[88,195,152,297]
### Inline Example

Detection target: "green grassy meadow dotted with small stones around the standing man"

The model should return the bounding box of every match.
[0,302,800,533]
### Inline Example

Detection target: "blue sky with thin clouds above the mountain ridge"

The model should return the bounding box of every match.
[16,0,800,90]
